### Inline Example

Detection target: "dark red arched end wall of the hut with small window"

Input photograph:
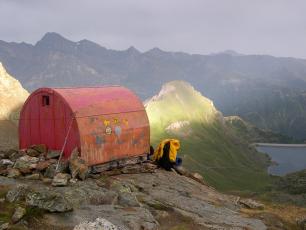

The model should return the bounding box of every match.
[19,88,80,157]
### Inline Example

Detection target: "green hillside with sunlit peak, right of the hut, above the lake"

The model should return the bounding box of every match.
[146,81,269,190]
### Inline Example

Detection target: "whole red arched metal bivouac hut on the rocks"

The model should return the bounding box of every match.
[19,86,150,166]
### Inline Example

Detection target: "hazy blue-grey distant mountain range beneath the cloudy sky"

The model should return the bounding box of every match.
[0,33,306,139]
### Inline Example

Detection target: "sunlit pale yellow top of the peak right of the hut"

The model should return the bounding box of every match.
[145,81,222,128]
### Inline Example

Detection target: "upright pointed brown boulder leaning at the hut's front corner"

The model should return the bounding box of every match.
[69,148,89,180]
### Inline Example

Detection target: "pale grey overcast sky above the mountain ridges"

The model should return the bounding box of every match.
[0,0,306,58]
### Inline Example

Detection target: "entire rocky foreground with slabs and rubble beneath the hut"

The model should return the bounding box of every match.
[0,146,304,230]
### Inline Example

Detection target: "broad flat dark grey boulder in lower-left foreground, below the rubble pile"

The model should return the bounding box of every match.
[26,190,73,212]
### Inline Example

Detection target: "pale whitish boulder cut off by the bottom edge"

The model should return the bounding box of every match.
[73,218,124,230]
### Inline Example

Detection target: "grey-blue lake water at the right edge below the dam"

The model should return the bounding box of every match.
[257,146,306,176]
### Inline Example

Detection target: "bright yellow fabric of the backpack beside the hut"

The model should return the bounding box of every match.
[152,139,180,162]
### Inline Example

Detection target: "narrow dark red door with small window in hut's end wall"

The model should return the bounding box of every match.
[39,92,55,147]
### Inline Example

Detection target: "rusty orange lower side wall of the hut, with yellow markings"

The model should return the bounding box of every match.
[78,111,150,165]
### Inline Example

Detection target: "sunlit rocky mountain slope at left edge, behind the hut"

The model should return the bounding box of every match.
[0,62,29,149]
